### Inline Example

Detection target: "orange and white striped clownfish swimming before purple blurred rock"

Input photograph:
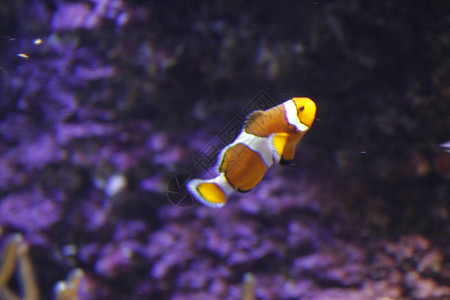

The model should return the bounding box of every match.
[186,97,316,208]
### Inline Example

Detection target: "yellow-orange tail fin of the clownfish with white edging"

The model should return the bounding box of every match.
[186,173,233,208]
